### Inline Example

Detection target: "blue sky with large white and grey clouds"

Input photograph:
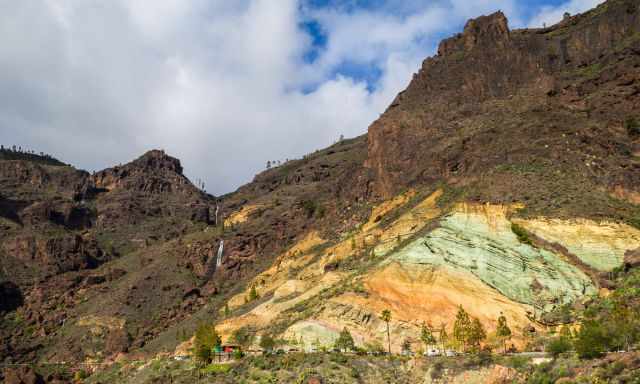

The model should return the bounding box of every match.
[0,0,602,194]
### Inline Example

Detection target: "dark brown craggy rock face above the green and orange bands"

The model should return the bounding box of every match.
[366,1,640,207]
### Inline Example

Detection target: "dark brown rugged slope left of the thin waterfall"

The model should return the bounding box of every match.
[0,151,218,361]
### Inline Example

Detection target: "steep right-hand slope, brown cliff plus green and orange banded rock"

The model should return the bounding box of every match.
[218,0,640,350]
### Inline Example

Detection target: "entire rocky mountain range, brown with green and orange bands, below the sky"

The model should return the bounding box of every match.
[0,0,640,382]
